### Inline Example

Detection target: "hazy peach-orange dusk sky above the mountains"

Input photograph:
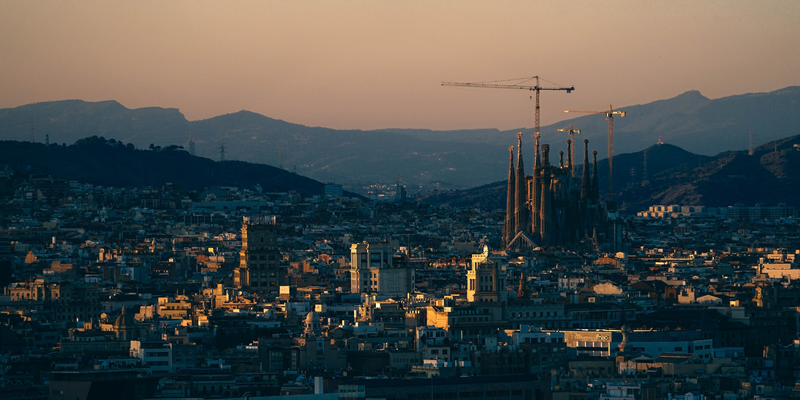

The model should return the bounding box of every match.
[0,0,800,129]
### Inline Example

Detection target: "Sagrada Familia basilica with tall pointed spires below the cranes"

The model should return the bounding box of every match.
[503,133,622,252]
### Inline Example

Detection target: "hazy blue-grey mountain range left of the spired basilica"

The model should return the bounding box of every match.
[0,100,507,193]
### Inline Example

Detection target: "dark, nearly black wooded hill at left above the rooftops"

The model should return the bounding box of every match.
[0,137,352,196]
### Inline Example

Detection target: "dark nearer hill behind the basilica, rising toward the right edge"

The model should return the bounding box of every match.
[420,135,800,212]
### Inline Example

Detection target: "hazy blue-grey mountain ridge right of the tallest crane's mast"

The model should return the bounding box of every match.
[520,86,800,161]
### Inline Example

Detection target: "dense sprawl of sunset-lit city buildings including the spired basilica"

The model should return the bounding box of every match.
[0,152,800,400]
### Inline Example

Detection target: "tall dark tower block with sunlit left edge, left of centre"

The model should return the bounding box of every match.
[234,219,286,296]
